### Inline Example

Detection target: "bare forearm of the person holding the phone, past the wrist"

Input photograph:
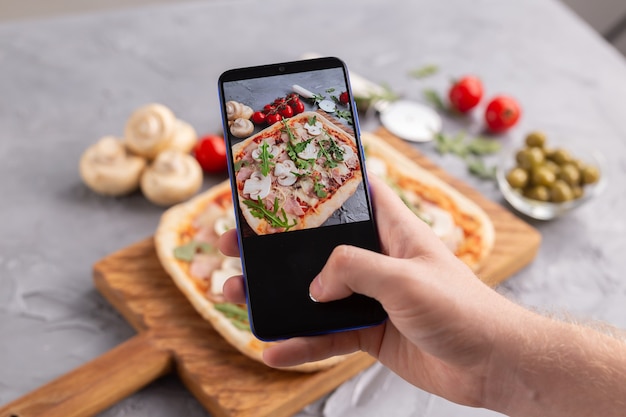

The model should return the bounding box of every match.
[490,312,626,417]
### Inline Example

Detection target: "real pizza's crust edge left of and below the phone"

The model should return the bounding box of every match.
[154,180,347,372]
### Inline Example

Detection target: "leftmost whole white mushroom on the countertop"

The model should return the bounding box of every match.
[79,136,146,196]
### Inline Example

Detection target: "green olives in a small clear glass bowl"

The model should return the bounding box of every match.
[496,132,606,220]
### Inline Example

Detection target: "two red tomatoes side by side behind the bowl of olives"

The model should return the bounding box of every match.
[448,75,522,133]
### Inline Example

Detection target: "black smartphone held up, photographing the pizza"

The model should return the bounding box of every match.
[218,57,387,341]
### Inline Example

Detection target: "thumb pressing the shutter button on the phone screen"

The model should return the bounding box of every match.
[309,245,411,305]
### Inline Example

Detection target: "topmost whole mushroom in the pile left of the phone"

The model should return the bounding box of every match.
[124,103,176,159]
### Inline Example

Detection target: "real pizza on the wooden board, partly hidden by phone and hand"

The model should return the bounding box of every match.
[155,127,494,372]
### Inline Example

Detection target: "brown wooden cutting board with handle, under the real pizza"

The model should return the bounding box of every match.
[0,129,541,417]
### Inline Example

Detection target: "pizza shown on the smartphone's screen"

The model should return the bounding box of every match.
[232,112,365,235]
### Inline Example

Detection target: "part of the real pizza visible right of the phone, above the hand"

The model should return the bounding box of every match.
[361,132,495,271]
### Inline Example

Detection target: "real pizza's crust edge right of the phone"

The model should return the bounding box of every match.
[361,132,495,271]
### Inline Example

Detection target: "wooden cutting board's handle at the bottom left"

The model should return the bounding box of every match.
[0,332,173,417]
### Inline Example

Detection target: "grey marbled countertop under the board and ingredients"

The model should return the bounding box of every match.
[0,0,626,417]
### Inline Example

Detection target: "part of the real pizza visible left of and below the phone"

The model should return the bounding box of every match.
[154,181,345,372]
